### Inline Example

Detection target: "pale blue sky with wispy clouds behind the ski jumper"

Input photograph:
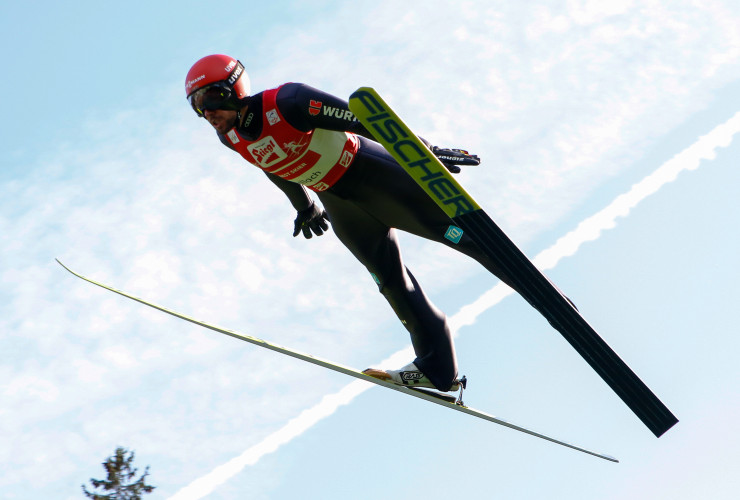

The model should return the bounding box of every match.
[0,0,740,499]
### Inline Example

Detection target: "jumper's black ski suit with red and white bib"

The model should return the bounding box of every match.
[219,83,524,391]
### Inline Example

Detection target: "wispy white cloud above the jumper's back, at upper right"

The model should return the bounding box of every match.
[247,1,740,244]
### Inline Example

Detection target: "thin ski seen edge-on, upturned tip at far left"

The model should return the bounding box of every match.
[56,259,619,462]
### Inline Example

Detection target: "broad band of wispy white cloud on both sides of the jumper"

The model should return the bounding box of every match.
[0,1,740,493]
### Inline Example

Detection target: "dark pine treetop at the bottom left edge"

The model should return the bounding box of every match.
[82,446,155,500]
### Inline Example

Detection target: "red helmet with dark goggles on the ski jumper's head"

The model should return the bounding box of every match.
[185,54,249,116]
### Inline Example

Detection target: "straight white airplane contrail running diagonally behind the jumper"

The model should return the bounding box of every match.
[169,112,740,500]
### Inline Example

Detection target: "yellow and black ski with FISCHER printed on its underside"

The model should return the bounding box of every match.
[349,87,678,437]
